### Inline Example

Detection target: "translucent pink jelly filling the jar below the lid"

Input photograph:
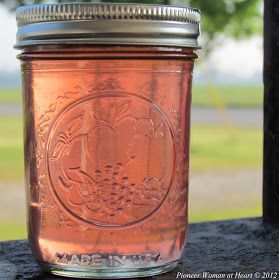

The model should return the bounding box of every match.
[21,47,195,268]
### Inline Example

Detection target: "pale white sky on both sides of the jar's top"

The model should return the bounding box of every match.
[0,5,263,87]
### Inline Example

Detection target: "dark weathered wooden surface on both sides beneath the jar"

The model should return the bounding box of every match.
[0,218,279,280]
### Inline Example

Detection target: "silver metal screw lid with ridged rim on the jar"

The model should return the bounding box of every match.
[15,3,200,48]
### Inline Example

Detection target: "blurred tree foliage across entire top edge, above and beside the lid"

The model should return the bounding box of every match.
[0,0,262,54]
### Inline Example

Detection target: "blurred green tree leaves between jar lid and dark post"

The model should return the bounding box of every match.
[189,0,263,53]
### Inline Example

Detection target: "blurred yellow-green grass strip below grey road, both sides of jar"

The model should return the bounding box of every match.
[0,116,262,182]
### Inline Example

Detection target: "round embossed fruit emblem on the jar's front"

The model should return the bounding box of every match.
[47,94,175,226]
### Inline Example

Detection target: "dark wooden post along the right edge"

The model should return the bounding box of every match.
[263,0,279,224]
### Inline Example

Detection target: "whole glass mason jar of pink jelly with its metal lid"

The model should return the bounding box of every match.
[16,3,200,278]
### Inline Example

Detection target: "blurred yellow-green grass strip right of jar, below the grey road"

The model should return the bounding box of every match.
[190,125,263,172]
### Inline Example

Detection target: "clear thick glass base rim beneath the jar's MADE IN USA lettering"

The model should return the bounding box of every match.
[39,261,178,279]
